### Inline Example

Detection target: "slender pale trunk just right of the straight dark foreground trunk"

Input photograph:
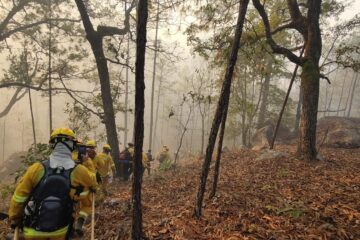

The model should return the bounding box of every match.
[149,0,160,152]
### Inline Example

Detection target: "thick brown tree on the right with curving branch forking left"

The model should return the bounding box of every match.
[253,0,322,159]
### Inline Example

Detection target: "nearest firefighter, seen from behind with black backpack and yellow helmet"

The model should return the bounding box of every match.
[9,128,97,240]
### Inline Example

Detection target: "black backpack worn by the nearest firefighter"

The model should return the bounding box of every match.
[24,160,74,232]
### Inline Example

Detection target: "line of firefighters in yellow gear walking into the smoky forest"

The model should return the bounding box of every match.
[9,128,170,240]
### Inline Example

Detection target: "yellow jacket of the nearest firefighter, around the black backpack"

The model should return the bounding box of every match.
[9,162,97,237]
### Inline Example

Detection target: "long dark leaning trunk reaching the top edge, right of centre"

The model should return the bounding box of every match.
[194,0,249,218]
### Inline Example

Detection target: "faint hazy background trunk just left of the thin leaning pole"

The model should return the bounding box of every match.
[256,56,273,129]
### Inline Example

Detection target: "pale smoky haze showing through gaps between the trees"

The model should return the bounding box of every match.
[0,1,360,163]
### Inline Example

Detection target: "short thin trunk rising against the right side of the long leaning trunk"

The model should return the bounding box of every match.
[209,106,228,199]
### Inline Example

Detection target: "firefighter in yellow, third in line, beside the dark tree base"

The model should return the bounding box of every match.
[94,144,116,195]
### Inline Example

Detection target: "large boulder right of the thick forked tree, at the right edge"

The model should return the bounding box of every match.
[317,117,360,148]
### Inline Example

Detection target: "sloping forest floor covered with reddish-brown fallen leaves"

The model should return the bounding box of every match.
[0,146,360,240]
